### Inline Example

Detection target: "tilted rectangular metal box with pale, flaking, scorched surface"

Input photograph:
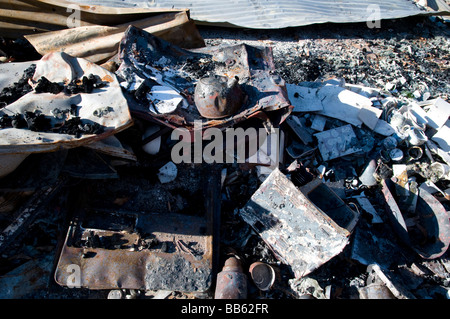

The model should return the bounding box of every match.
[240,169,359,278]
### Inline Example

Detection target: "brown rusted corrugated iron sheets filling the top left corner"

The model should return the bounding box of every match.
[0,0,201,43]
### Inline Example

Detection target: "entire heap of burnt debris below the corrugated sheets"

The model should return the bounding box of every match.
[0,11,450,299]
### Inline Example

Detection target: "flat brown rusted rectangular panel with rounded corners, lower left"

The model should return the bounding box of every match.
[55,211,212,292]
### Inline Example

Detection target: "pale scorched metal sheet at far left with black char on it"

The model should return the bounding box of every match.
[0,52,133,154]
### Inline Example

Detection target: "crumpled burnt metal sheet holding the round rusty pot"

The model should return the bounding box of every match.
[116,26,292,130]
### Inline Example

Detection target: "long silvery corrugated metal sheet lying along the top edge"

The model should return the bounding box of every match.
[77,0,446,29]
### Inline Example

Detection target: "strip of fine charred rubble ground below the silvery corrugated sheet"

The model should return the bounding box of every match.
[203,17,450,100]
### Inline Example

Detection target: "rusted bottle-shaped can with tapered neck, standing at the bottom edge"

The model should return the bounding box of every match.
[214,257,247,299]
